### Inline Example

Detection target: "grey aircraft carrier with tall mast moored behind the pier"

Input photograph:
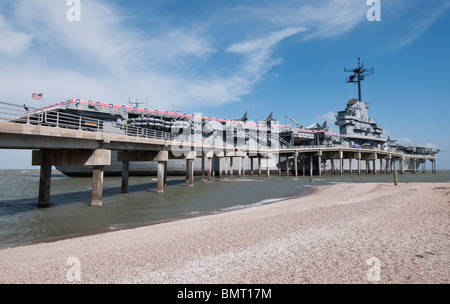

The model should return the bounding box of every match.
[20,58,439,176]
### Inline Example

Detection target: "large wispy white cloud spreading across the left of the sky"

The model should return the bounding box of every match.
[0,0,370,108]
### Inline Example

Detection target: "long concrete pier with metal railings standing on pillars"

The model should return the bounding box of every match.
[0,103,437,207]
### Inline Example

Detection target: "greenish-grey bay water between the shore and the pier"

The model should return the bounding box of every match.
[0,170,450,248]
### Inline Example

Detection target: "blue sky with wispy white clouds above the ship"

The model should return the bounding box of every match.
[0,0,450,169]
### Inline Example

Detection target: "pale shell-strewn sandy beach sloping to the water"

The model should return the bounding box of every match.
[0,183,450,284]
